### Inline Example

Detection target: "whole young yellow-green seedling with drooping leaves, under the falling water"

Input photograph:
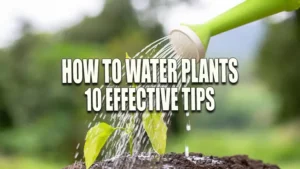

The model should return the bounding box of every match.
[84,53,168,169]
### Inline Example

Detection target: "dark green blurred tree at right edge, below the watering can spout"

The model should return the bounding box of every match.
[258,10,300,122]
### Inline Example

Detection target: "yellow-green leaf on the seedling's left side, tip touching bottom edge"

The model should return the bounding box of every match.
[84,123,116,169]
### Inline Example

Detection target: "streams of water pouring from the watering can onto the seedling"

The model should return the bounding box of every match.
[74,36,191,162]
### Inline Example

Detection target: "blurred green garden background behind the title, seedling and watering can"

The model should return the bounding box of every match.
[0,0,300,169]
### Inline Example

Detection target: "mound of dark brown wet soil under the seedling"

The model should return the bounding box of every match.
[64,153,279,169]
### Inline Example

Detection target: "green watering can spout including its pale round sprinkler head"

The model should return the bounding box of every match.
[170,0,300,60]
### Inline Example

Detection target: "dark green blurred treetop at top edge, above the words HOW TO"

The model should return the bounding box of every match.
[65,0,140,43]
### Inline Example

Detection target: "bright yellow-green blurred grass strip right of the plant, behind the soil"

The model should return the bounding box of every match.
[168,130,300,169]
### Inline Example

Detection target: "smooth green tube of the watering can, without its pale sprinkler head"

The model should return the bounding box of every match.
[205,0,300,36]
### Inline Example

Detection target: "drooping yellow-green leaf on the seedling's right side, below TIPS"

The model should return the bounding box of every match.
[143,111,168,154]
